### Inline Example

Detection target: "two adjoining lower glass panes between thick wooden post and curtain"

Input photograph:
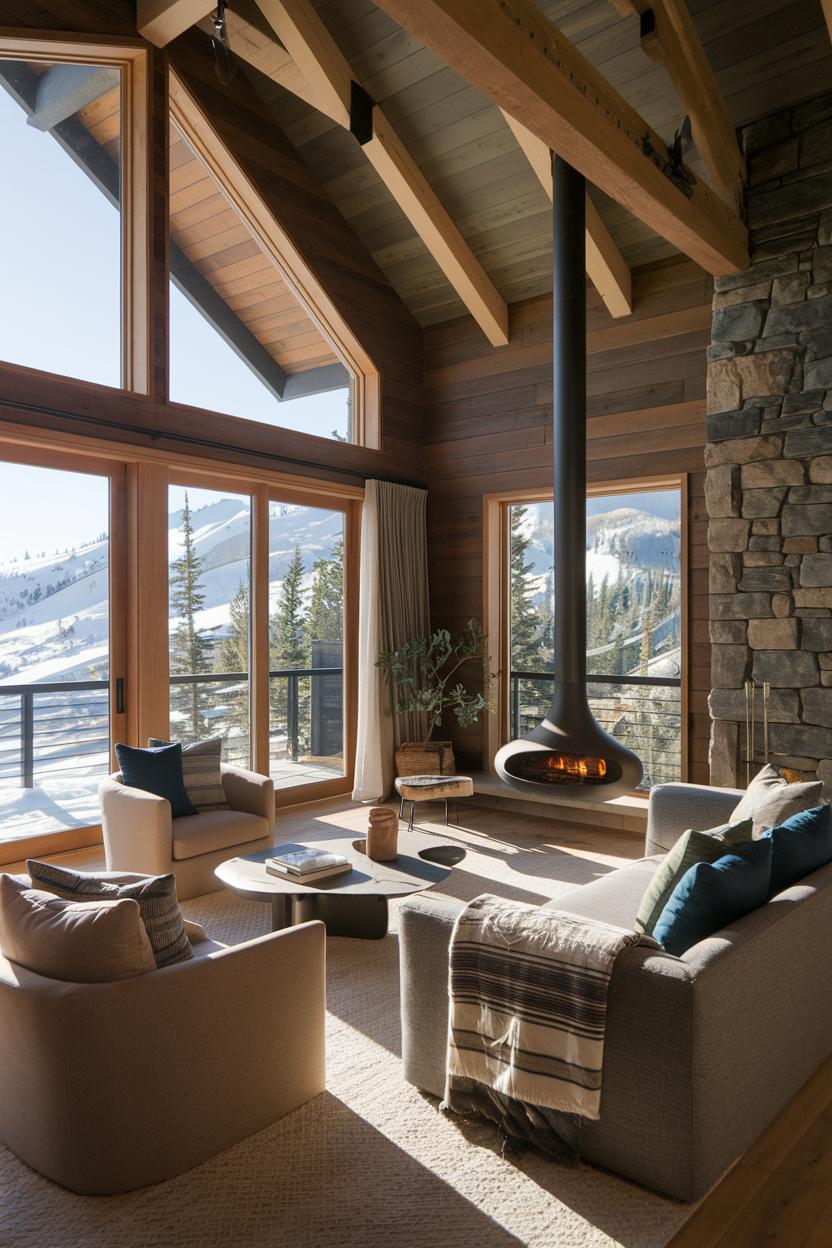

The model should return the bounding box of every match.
[163,484,354,792]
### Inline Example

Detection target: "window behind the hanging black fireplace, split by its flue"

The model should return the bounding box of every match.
[508,488,684,787]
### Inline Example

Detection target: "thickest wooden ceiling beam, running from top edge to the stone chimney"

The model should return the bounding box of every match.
[366,0,748,275]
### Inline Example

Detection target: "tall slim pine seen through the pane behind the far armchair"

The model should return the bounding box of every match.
[170,494,212,740]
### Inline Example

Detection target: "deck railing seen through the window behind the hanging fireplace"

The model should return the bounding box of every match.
[509,671,682,789]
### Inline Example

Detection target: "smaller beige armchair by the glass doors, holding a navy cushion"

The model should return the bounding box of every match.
[99,765,274,900]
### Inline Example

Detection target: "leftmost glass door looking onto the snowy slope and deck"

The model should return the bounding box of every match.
[0,456,125,840]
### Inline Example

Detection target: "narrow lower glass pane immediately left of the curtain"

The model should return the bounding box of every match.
[268,502,344,789]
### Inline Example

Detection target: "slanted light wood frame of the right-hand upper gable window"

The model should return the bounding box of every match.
[166,67,382,451]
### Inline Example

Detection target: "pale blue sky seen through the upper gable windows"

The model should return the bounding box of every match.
[0,69,346,454]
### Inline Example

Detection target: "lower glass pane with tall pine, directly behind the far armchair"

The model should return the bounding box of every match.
[168,485,251,768]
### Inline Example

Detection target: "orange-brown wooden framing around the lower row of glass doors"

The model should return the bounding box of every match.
[0,421,364,866]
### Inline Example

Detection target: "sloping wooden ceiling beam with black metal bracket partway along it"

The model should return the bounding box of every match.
[251,0,509,347]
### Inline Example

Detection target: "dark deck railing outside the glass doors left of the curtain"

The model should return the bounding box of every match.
[0,666,343,789]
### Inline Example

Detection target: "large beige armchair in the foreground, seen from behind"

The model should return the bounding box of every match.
[0,922,326,1196]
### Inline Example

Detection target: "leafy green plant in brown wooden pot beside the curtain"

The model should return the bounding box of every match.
[377,620,490,776]
